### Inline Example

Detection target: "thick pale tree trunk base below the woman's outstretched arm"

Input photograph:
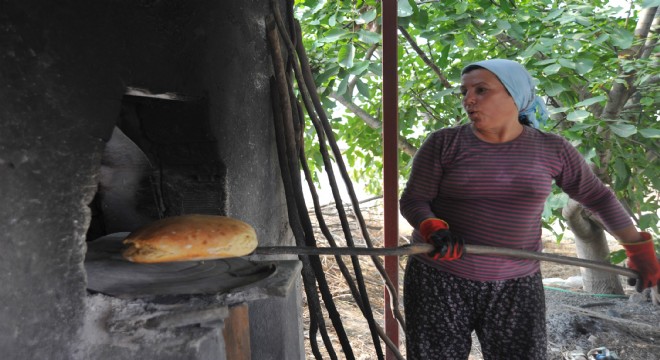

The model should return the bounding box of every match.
[562,200,623,294]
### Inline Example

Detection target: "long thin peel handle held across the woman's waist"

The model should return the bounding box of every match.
[254,244,639,278]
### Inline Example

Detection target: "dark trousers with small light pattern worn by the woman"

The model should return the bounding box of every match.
[403,257,547,360]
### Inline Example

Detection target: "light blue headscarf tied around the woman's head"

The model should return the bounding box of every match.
[461,59,548,128]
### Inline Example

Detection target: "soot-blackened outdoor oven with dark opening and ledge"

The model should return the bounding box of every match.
[0,0,304,360]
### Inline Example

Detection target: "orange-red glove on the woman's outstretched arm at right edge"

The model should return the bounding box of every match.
[621,232,660,298]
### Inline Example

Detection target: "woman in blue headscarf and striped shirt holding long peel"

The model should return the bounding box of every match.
[400,59,660,360]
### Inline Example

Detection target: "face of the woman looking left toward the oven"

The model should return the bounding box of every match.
[461,68,519,131]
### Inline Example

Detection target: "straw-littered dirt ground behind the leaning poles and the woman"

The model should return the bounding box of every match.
[304,200,660,360]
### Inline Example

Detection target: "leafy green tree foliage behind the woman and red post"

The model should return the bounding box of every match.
[295,0,660,242]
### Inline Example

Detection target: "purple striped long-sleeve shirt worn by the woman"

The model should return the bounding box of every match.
[400,125,632,281]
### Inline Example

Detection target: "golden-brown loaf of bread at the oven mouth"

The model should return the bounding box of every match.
[122,215,257,263]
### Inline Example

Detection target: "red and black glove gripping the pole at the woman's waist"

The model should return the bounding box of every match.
[419,218,464,261]
